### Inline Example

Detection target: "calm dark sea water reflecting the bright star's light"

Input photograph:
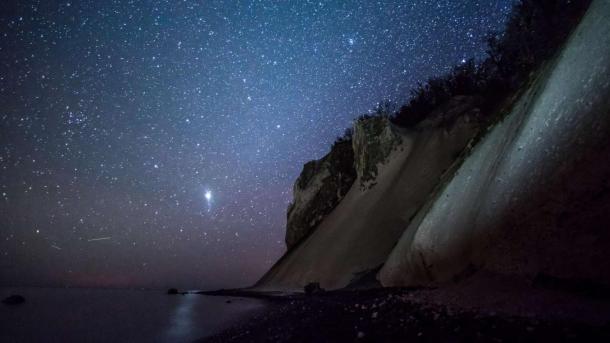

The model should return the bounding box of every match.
[0,288,264,342]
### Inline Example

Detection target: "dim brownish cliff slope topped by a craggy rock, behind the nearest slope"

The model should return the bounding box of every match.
[255,109,480,290]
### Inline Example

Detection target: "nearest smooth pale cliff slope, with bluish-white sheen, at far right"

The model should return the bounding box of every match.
[378,0,610,286]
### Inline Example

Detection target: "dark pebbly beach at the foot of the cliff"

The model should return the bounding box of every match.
[202,289,610,342]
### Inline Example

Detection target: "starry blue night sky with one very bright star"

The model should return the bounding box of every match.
[0,0,512,288]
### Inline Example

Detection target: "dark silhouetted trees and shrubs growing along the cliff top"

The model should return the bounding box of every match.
[330,0,591,142]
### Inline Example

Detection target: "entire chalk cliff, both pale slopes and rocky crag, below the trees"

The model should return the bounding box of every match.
[254,0,610,290]
